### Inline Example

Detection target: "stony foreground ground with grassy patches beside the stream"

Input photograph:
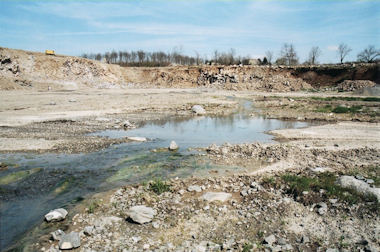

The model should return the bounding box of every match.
[36,141,380,251]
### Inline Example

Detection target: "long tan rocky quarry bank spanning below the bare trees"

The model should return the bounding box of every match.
[0,48,379,92]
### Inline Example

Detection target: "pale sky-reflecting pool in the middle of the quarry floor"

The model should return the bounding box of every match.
[90,102,309,149]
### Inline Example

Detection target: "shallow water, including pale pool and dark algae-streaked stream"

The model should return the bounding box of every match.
[0,100,308,250]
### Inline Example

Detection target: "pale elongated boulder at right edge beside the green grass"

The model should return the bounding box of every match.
[336,176,380,201]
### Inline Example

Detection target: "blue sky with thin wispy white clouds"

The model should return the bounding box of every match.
[0,0,380,63]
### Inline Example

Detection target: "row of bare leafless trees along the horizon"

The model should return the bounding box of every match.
[81,43,380,67]
